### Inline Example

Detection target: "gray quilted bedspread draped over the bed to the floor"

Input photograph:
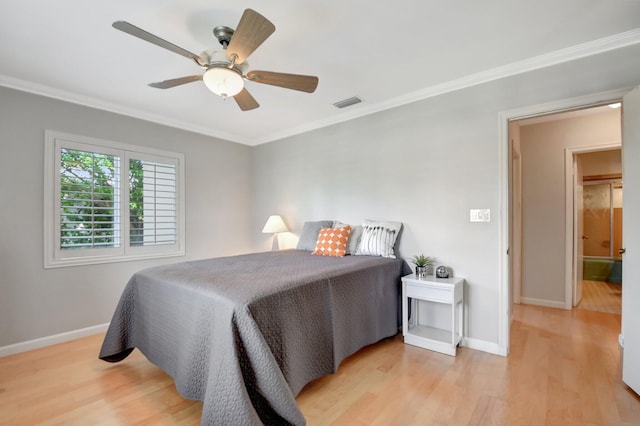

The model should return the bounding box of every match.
[100,250,406,425]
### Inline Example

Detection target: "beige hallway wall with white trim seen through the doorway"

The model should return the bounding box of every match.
[509,104,621,316]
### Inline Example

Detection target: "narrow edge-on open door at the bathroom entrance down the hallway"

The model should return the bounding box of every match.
[573,154,587,307]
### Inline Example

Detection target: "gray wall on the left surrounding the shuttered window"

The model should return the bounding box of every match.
[0,87,253,347]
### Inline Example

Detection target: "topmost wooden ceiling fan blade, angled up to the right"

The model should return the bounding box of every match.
[227,9,276,64]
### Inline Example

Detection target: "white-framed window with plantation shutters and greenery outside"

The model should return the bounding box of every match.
[44,131,184,268]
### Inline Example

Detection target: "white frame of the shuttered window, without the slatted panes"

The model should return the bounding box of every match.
[44,130,185,268]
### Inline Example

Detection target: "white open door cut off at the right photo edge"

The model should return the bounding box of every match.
[621,87,640,394]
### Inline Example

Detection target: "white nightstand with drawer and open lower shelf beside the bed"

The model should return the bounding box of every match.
[402,274,464,356]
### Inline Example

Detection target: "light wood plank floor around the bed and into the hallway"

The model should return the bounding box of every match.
[0,305,640,426]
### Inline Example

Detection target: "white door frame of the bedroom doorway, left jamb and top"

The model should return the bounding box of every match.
[498,87,632,355]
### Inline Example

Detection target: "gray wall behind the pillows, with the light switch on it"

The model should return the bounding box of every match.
[252,46,640,349]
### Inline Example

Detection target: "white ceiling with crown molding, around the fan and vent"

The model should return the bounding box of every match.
[0,0,640,145]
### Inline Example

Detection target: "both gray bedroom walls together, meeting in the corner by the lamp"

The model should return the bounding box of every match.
[0,42,640,349]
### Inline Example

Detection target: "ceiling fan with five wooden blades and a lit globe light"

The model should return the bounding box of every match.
[113,9,318,111]
